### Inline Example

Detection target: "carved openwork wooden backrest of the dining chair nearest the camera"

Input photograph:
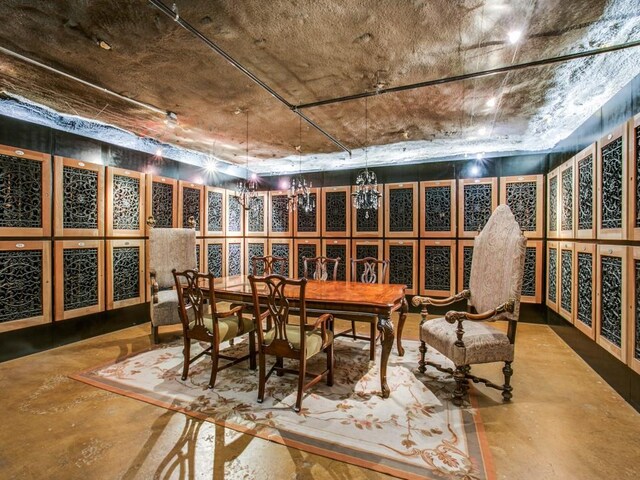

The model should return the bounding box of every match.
[249,275,307,351]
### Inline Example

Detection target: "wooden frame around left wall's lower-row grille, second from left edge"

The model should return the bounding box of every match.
[54,239,105,321]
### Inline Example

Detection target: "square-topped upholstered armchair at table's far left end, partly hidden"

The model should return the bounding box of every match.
[149,228,196,343]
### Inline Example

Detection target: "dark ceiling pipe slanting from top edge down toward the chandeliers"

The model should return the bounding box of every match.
[149,0,351,155]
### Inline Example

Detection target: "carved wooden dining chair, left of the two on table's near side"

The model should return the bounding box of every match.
[172,269,256,388]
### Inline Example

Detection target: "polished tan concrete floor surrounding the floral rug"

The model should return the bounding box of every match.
[0,315,640,480]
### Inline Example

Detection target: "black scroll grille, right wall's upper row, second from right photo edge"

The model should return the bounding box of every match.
[600,137,622,228]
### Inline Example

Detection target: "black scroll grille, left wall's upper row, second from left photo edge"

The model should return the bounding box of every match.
[62,166,98,228]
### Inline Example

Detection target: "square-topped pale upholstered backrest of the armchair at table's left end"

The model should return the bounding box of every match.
[149,228,197,289]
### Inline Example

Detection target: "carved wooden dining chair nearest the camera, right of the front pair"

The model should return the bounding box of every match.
[249,275,333,412]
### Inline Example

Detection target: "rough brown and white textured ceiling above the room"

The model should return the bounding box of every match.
[0,0,640,173]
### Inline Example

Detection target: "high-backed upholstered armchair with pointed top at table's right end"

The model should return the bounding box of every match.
[413,205,526,405]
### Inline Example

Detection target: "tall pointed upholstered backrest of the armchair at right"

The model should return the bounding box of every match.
[469,205,527,320]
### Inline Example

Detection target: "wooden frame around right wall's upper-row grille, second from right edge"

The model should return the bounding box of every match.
[596,125,630,240]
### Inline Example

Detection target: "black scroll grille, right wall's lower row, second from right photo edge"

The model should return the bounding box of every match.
[600,256,623,347]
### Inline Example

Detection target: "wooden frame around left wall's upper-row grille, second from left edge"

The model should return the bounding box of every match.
[53,155,105,237]
